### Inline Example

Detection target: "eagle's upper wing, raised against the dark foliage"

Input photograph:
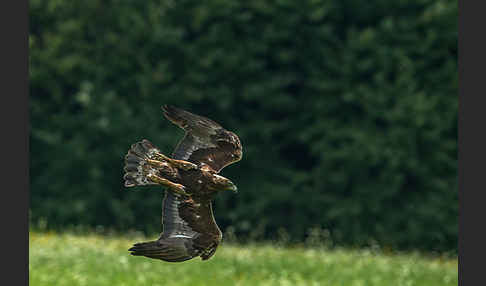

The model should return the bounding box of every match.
[163,105,242,172]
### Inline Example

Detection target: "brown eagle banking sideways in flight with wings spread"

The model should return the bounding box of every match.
[123,105,243,262]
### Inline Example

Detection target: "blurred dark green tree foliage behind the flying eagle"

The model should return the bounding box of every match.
[29,0,458,251]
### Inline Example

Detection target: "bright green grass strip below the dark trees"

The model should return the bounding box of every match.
[29,232,458,286]
